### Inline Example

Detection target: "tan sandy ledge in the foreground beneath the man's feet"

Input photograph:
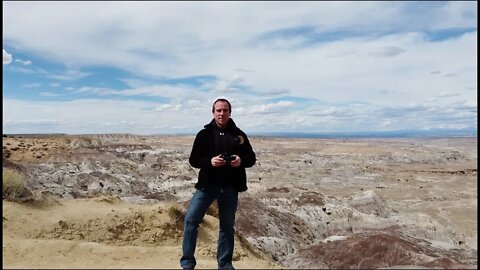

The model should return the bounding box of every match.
[2,197,278,269]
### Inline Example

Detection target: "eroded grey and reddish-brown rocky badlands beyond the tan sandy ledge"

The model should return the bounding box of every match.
[3,134,477,269]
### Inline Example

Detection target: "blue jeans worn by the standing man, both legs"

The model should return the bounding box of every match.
[180,188,238,269]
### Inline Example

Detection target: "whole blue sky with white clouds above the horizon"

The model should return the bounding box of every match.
[2,1,477,134]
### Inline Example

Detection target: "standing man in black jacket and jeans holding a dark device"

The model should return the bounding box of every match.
[180,99,256,269]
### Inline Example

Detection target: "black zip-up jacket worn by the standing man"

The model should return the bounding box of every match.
[189,119,256,192]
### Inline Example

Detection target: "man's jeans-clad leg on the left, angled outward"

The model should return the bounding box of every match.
[180,189,215,269]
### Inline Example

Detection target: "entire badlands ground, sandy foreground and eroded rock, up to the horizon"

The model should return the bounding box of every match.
[3,134,477,269]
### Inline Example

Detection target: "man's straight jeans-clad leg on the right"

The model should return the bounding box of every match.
[217,188,238,269]
